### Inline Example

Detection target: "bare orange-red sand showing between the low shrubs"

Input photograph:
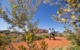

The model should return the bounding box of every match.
[8,37,70,50]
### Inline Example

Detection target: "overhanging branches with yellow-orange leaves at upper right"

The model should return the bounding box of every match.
[43,0,80,29]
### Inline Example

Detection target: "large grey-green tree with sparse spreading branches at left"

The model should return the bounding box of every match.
[0,0,42,32]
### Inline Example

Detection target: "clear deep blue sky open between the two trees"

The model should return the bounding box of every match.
[0,0,70,32]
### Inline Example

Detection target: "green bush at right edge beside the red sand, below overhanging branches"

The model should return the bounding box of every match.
[64,33,80,46]
